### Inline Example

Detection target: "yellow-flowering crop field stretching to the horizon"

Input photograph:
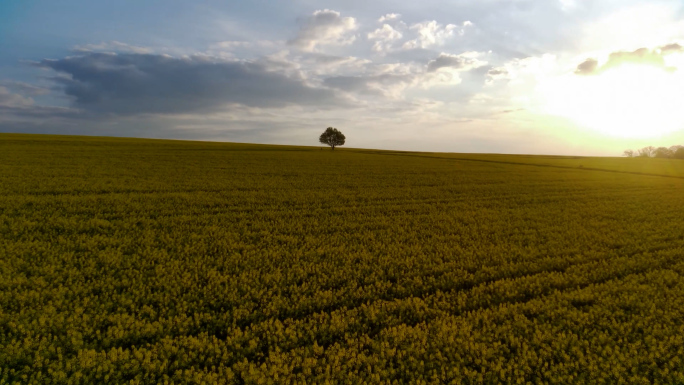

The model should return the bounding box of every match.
[0,134,684,385]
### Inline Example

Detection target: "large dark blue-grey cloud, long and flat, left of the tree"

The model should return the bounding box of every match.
[38,53,344,115]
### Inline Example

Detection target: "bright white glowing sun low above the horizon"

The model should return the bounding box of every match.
[539,60,684,138]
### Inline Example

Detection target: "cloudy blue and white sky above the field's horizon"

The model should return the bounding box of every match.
[0,0,684,156]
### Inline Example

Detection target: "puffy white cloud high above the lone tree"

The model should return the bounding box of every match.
[288,9,358,51]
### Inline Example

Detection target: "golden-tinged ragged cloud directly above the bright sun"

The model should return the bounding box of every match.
[575,44,682,75]
